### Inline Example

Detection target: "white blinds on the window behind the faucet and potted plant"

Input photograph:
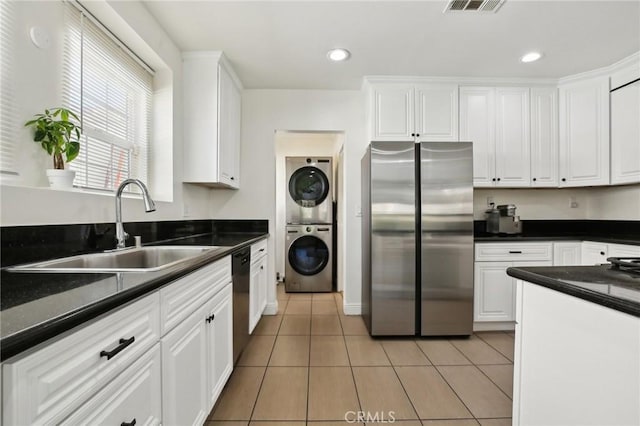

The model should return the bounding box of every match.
[62,3,153,191]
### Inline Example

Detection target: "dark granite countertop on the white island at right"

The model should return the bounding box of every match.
[507,264,640,317]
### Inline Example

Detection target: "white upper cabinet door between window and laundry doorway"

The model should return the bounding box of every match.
[218,66,241,188]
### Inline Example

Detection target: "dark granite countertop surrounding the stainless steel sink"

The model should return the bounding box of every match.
[0,232,268,360]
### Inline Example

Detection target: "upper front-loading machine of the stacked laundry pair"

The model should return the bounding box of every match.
[285,157,333,224]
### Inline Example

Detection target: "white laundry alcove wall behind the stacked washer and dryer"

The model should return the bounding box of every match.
[274,131,342,286]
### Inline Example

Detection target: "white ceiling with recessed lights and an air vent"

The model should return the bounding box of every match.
[144,0,640,89]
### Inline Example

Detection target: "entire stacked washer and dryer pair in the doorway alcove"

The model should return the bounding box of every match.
[285,157,333,292]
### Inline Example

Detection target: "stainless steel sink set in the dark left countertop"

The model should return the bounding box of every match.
[7,246,226,273]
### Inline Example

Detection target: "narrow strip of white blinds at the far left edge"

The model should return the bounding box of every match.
[0,1,18,175]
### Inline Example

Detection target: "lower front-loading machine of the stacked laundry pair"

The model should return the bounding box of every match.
[284,225,333,292]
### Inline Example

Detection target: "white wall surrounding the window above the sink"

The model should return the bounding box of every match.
[0,1,211,226]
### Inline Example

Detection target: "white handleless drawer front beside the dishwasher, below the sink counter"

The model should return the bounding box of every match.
[160,256,231,335]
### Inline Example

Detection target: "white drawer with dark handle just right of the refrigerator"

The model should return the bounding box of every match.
[476,243,553,262]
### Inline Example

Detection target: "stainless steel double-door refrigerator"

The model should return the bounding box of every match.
[362,142,473,336]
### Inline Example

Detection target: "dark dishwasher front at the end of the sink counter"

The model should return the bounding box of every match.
[231,247,251,365]
